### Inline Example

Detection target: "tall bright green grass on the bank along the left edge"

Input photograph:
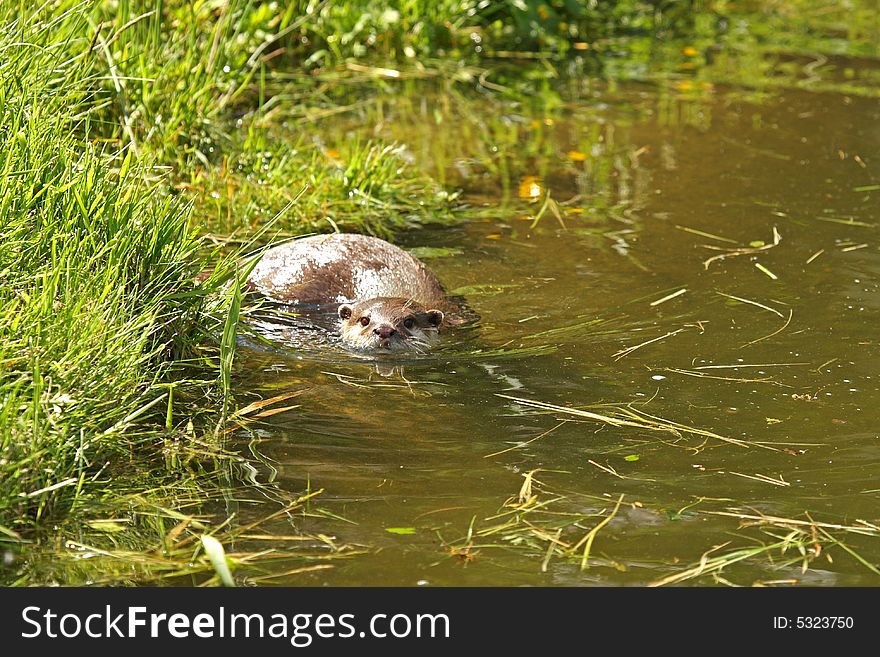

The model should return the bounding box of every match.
[0,4,235,529]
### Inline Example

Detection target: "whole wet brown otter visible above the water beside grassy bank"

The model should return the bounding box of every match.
[247,233,470,353]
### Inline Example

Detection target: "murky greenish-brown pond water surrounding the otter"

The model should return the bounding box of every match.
[229,61,880,585]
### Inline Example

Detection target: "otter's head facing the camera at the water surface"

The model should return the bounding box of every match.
[338,297,443,352]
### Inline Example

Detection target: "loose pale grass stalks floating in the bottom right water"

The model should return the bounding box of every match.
[441,463,880,586]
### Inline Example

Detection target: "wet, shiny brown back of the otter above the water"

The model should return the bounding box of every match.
[248,233,451,311]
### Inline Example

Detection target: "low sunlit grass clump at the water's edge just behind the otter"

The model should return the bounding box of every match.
[187,134,455,238]
